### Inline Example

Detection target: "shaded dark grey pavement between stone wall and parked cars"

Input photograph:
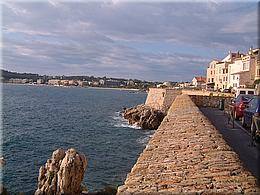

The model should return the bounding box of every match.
[200,107,260,180]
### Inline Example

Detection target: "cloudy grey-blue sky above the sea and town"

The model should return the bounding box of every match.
[0,0,258,81]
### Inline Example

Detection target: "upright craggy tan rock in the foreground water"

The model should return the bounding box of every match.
[35,148,87,195]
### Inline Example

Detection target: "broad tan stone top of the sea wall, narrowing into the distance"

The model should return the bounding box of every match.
[118,95,260,194]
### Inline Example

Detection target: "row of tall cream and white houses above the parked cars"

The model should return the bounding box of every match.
[207,48,260,90]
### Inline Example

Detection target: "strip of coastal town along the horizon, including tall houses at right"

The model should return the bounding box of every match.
[1,47,260,93]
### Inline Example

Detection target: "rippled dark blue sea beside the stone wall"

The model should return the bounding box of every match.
[2,84,153,194]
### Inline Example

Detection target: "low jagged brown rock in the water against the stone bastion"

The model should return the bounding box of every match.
[122,104,166,129]
